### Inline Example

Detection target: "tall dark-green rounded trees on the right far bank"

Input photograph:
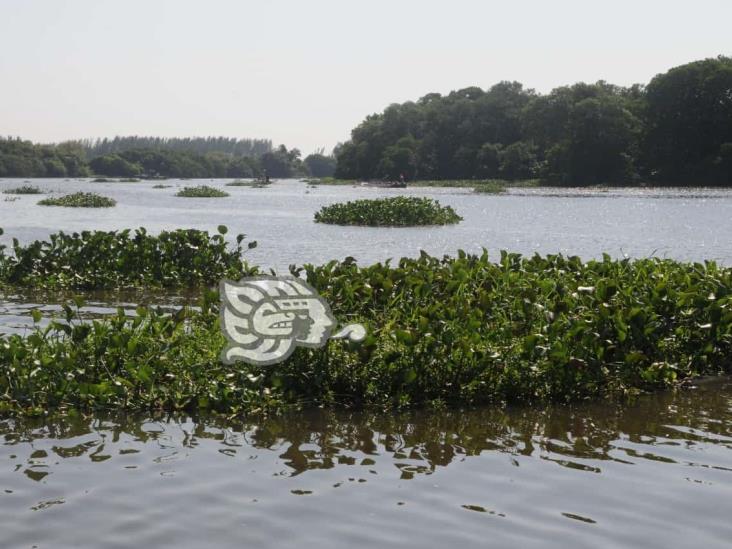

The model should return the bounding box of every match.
[335,56,732,185]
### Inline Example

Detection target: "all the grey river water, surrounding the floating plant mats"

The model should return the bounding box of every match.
[0,180,732,549]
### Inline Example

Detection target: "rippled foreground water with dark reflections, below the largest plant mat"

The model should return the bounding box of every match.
[0,380,732,547]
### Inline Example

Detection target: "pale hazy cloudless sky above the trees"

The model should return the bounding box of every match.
[0,0,732,154]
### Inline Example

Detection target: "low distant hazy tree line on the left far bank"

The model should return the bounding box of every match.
[0,138,335,178]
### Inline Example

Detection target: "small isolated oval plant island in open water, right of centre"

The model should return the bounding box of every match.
[315,196,463,227]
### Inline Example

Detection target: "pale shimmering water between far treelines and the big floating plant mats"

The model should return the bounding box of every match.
[0,179,732,270]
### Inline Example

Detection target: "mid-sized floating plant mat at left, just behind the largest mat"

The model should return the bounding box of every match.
[0,225,256,289]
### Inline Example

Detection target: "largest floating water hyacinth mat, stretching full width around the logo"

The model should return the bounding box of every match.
[0,249,732,413]
